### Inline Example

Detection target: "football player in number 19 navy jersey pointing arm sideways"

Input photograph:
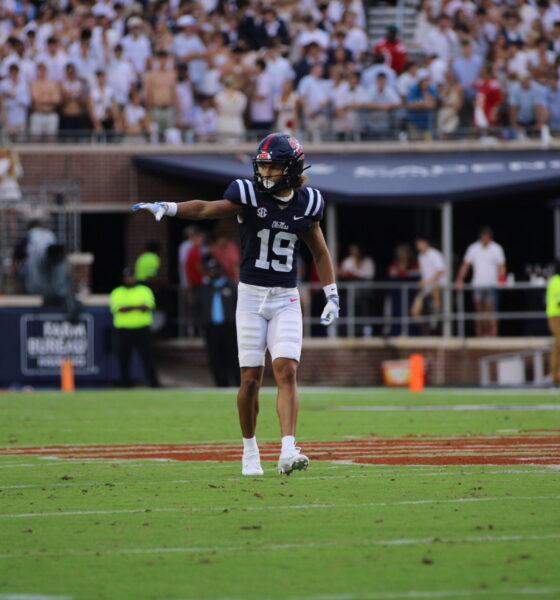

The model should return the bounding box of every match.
[132,133,339,475]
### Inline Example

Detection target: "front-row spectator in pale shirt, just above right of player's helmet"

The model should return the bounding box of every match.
[297,65,329,141]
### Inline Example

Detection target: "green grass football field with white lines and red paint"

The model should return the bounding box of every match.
[0,389,560,600]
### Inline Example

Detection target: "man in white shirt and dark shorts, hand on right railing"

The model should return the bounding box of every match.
[455,227,506,337]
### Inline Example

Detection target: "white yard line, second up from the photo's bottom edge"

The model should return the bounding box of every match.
[0,534,560,559]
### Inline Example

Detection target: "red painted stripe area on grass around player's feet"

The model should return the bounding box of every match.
[0,431,560,465]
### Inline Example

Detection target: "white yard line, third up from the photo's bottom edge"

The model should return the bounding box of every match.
[0,496,560,516]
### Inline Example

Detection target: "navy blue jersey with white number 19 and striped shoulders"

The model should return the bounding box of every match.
[224,179,325,287]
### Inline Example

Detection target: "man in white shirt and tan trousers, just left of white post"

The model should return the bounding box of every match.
[410,235,446,335]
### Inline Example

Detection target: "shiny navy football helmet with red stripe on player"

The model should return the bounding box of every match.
[253,133,305,193]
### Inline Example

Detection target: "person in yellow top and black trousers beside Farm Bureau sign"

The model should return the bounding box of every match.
[110,269,160,387]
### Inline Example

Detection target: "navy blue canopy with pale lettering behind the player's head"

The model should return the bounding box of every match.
[134,151,560,205]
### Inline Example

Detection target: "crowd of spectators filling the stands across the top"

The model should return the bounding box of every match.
[0,0,560,143]
